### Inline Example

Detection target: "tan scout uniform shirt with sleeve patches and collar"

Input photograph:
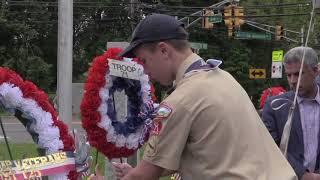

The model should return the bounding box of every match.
[144,54,297,180]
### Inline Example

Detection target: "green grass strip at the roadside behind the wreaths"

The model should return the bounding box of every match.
[0,142,170,180]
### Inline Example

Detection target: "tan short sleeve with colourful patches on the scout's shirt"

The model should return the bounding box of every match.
[143,102,192,171]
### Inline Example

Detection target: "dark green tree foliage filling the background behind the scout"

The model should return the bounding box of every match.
[0,0,320,104]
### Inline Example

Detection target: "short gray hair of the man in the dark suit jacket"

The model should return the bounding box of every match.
[283,46,319,67]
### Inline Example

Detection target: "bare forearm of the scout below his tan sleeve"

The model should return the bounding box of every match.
[121,160,165,180]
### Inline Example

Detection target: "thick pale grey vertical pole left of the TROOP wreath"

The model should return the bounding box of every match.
[57,0,73,127]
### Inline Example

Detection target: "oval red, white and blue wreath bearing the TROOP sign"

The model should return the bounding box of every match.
[81,48,156,159]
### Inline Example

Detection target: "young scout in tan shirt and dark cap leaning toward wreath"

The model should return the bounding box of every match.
[105,14,297,180]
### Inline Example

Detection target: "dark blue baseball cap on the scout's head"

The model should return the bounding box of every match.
[119,14,188,57]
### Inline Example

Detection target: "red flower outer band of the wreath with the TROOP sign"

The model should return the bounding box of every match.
[81,48,149,159]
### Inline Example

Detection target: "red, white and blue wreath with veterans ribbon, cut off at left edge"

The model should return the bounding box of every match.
[0,67,77,180]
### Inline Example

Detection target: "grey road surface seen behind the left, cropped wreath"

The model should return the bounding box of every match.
[0,116,85,143]
